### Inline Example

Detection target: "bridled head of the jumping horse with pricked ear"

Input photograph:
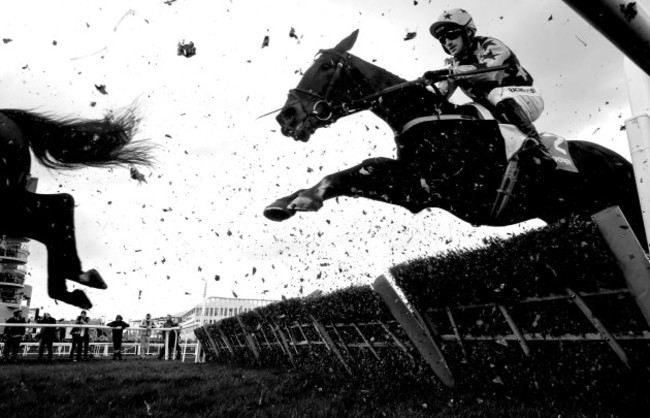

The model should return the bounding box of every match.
[276,30,360,142]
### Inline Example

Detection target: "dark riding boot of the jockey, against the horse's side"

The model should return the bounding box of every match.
[496,99,557,170]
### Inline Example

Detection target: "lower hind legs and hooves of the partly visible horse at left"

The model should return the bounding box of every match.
[20,193,106,309]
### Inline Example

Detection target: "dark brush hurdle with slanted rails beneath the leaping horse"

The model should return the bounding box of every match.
[195,212,650,402]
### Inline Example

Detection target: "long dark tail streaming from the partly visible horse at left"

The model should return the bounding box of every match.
[0,107,153,169]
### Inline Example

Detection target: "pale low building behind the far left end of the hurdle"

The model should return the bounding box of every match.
[179,297,277,339]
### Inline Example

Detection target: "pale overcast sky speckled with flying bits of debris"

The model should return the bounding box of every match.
[0,0,648,319]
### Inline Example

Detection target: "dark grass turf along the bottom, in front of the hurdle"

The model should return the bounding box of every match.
[0,359,635,418]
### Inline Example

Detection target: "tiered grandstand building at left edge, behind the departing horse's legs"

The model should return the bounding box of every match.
[0,178,38,328]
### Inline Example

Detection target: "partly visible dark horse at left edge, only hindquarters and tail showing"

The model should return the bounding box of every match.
[0,108,152,309]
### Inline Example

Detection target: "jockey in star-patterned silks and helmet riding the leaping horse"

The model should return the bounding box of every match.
[424,9,556,168]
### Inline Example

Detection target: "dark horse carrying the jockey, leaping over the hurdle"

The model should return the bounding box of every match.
[264,31,646,250]
